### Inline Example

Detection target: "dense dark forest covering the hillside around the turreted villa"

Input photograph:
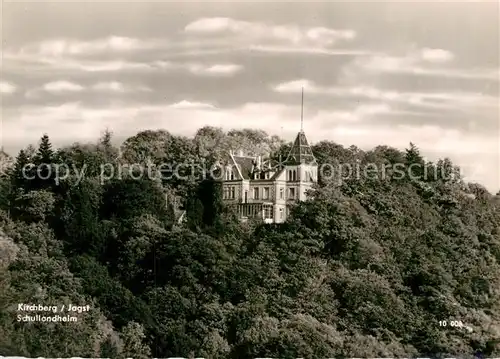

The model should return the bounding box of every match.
[0,127,500,359]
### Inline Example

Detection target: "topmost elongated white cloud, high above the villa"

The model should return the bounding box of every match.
[184,17,356,47]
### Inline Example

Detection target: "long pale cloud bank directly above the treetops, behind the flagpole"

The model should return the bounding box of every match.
[3,101,500,191]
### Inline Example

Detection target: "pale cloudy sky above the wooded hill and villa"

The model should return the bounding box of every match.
[0,1,500,192]
